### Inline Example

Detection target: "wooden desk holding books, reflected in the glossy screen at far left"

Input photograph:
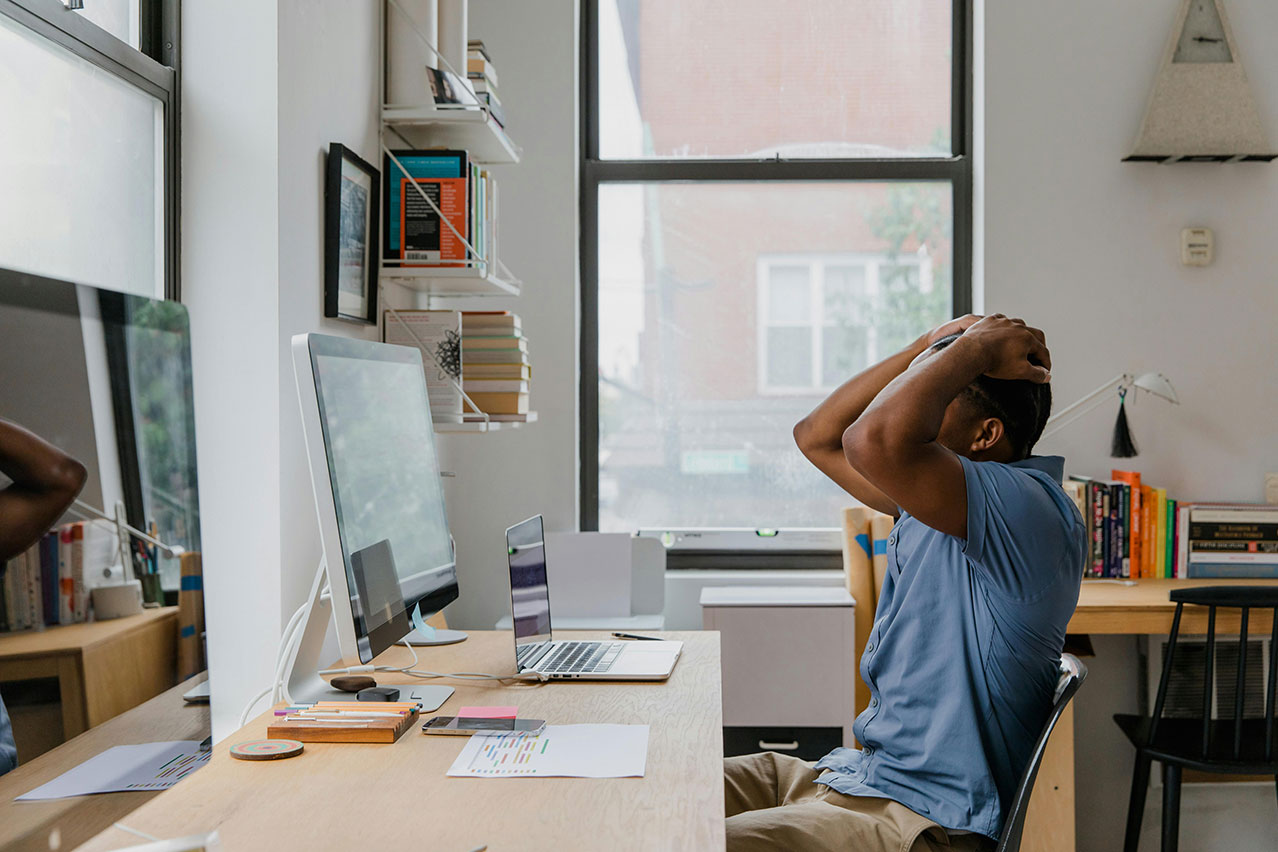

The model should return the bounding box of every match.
[0,607,178,740]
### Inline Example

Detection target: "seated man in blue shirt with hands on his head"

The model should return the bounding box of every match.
[725,314,1085,852]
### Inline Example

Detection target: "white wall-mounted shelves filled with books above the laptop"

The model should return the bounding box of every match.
[380,11,537,432]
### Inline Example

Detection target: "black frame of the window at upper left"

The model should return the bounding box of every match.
[0,0,181,301]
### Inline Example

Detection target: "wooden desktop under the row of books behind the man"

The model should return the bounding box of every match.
[1068,580,1278,635]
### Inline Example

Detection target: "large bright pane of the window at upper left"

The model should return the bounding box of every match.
[0,15,164,296]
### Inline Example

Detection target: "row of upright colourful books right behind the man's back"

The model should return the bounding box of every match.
[1065,470,1183,579]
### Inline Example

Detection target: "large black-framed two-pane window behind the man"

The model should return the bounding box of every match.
[581,0,971,544]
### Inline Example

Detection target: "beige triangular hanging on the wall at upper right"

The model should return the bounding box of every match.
[1125,0,1278,162]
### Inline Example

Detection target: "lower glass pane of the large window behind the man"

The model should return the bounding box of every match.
[598,181,952,531]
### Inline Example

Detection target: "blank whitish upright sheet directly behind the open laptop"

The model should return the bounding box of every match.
[546,533,631,618]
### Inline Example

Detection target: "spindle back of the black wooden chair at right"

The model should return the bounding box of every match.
[1149,586,1278,761]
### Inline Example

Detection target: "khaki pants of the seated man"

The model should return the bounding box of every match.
[723,751,994,852]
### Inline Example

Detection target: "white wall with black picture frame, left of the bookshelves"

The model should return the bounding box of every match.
[183,0,412,738]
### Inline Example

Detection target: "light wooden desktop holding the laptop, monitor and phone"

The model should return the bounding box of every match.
[74,631,725,852]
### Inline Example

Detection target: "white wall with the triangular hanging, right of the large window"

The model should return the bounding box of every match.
[983,0,1278,852]
